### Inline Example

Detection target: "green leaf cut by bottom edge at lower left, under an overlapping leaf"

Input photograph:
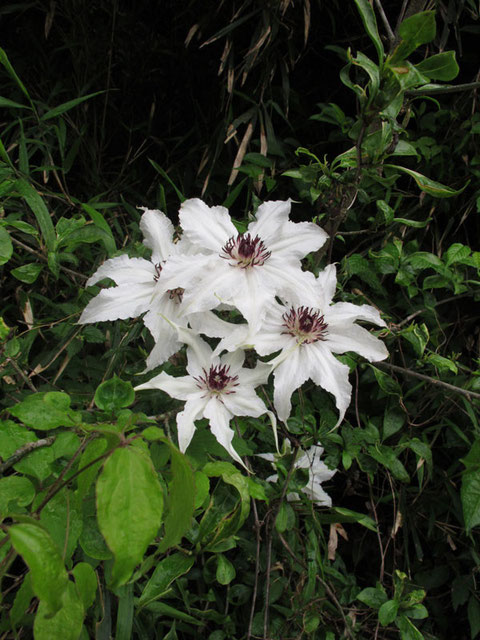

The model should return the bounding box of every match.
[33,582,85,640]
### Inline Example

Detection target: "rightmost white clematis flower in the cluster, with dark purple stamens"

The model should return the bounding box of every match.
[249,265,388,426]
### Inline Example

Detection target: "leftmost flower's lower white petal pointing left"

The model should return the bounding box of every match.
[78,281,155,324]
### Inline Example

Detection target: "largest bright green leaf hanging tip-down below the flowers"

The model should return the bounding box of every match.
[97,447,163,588]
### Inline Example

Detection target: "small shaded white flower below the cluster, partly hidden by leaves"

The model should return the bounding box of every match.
[259,445,337,507]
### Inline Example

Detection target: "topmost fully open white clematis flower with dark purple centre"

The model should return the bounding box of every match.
[162,198,328,326]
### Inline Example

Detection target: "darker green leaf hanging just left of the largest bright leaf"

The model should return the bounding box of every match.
[40,489,83,561]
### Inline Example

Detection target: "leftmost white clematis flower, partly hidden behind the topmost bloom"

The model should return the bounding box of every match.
[79,207,212,371]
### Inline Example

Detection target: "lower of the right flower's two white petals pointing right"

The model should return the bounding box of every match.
[325,323,388,362]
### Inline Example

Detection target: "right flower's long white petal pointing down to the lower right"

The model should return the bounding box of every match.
[303,342,352,426]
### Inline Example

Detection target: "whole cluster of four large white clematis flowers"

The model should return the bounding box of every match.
[79,198,387,472]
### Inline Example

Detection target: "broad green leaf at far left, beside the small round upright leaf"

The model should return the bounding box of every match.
[8,391,77,431]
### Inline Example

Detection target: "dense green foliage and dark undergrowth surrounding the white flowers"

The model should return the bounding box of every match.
[0,0,480,640]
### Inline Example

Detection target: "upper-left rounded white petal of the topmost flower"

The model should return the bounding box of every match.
[179,198,238,253]
